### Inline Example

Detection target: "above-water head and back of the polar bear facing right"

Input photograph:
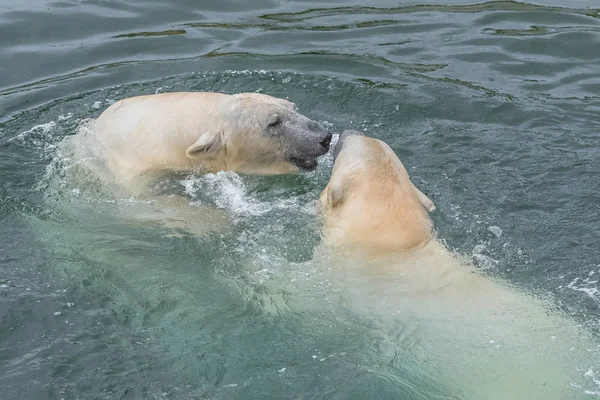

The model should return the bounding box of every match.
[81,92,332,187]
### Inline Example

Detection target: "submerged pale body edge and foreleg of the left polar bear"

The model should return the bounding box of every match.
[51,120,229,239]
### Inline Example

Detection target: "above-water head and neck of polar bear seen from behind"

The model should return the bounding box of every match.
[320,131,435,253]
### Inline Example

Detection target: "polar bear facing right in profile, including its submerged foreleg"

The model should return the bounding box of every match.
[62,92,332,237]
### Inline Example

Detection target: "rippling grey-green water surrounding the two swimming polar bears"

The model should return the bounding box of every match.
[0,0,600,399]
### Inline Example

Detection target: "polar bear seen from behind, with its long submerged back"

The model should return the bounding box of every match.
[320,131,600,400]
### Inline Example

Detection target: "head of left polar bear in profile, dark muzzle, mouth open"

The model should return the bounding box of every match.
[186,93,331,174]
